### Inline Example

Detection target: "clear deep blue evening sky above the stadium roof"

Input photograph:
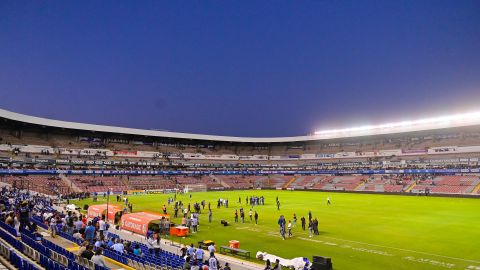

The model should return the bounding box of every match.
[0,0,480,136]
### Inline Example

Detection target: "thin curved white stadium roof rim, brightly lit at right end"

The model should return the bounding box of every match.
[0,109,480,143]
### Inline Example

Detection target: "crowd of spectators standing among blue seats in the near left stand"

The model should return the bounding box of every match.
[0,187,176,267]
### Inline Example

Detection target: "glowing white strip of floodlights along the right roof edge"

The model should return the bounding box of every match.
[314,112,480,137]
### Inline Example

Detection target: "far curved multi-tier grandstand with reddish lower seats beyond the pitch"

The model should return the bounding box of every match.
[0,106,480,195]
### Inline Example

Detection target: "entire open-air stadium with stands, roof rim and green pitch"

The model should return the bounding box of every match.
[0,110,480,270]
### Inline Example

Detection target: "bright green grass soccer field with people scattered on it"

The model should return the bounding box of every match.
[79,190,480,269]
